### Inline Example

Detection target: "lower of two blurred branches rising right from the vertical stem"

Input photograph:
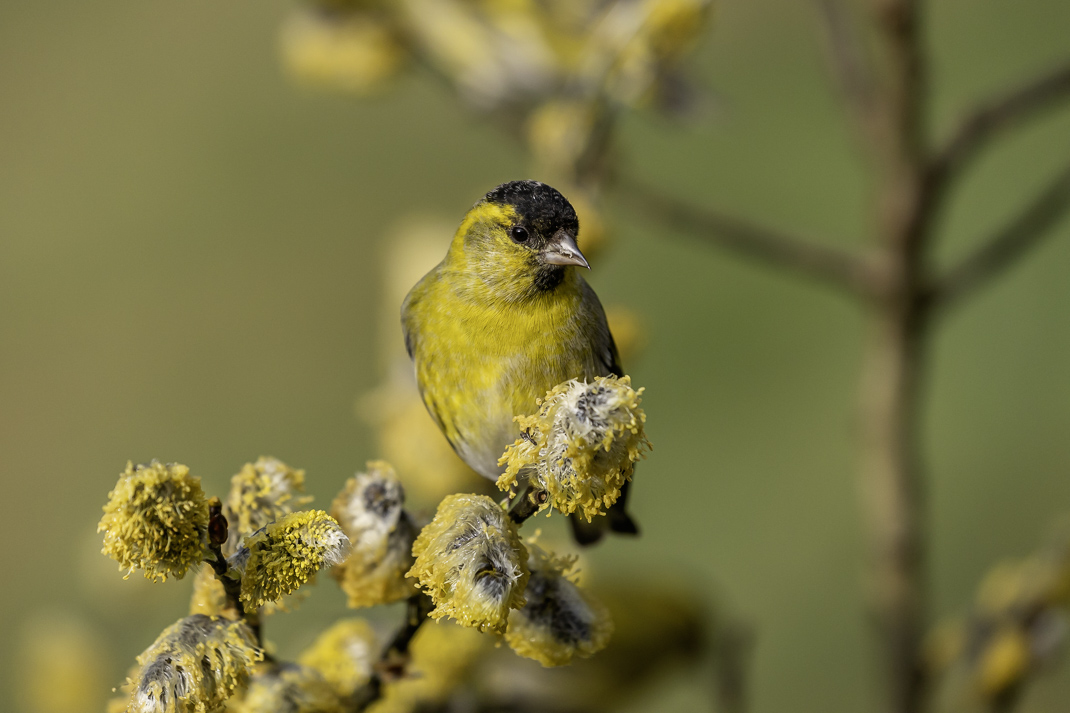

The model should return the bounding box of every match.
[923,164,1070,308]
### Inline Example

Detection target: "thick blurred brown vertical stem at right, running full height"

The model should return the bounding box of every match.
[859,0,935,713]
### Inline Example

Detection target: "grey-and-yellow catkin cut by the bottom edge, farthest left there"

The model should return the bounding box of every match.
[127,615,263,713]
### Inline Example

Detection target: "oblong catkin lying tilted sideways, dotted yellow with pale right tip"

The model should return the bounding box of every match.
[228,510,349,607]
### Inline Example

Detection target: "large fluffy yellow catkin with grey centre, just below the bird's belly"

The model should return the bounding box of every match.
[409,494,528,633]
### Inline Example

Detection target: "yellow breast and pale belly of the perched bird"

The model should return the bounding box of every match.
[403,263,608,477]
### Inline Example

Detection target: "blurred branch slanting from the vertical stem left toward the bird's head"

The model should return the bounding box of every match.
[616,179,877,295]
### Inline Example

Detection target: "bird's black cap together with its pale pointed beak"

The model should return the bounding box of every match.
[484,181,591,269]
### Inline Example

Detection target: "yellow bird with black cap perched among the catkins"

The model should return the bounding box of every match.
[401,180,638,544]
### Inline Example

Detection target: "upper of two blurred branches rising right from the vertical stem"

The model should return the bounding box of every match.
[929,62,1070,186]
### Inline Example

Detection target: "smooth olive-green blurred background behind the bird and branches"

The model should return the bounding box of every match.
[0,0,1070,713]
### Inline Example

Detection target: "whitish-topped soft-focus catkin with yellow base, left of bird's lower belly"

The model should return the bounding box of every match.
[331,460,416,609]
